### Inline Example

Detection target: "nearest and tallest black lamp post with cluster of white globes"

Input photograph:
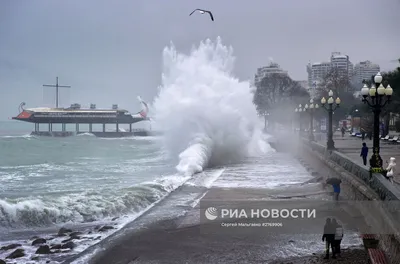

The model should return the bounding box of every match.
[361,72,393,172]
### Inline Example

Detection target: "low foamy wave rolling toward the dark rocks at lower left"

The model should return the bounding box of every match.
[0,179,176,228]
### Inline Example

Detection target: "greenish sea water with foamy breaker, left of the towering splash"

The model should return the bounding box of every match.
[0,122,180,229]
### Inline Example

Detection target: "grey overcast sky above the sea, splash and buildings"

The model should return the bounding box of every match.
[0,0,400,120]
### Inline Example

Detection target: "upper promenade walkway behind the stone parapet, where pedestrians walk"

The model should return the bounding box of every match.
[316,132,400,184]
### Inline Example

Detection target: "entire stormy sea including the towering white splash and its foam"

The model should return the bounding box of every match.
[0,39,362,263]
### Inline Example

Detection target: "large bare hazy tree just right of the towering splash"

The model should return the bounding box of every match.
[253,73,309,129]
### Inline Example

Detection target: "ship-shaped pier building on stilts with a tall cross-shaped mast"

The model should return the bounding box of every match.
[12,77,151,138]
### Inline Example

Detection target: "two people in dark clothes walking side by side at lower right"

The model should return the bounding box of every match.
[322,218,343,259]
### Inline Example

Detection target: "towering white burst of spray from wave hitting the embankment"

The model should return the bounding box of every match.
[153,37,271,175]
